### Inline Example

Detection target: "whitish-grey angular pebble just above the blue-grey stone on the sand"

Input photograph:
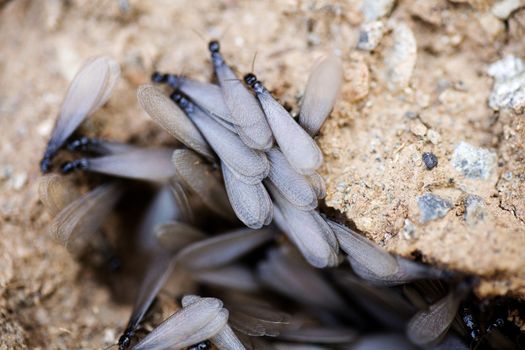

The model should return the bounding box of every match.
[452,141,496,180]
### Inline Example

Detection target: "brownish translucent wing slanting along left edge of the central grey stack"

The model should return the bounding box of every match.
[172,149,235,219]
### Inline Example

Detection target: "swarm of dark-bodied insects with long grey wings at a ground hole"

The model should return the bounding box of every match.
[34,41,520,349]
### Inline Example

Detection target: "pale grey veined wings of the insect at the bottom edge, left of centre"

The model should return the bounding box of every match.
[132,298,228,350]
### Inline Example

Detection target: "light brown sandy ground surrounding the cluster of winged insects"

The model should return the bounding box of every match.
[0,0,525,349]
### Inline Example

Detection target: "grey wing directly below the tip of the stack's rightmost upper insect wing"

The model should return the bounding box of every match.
[266,148,317,210]
